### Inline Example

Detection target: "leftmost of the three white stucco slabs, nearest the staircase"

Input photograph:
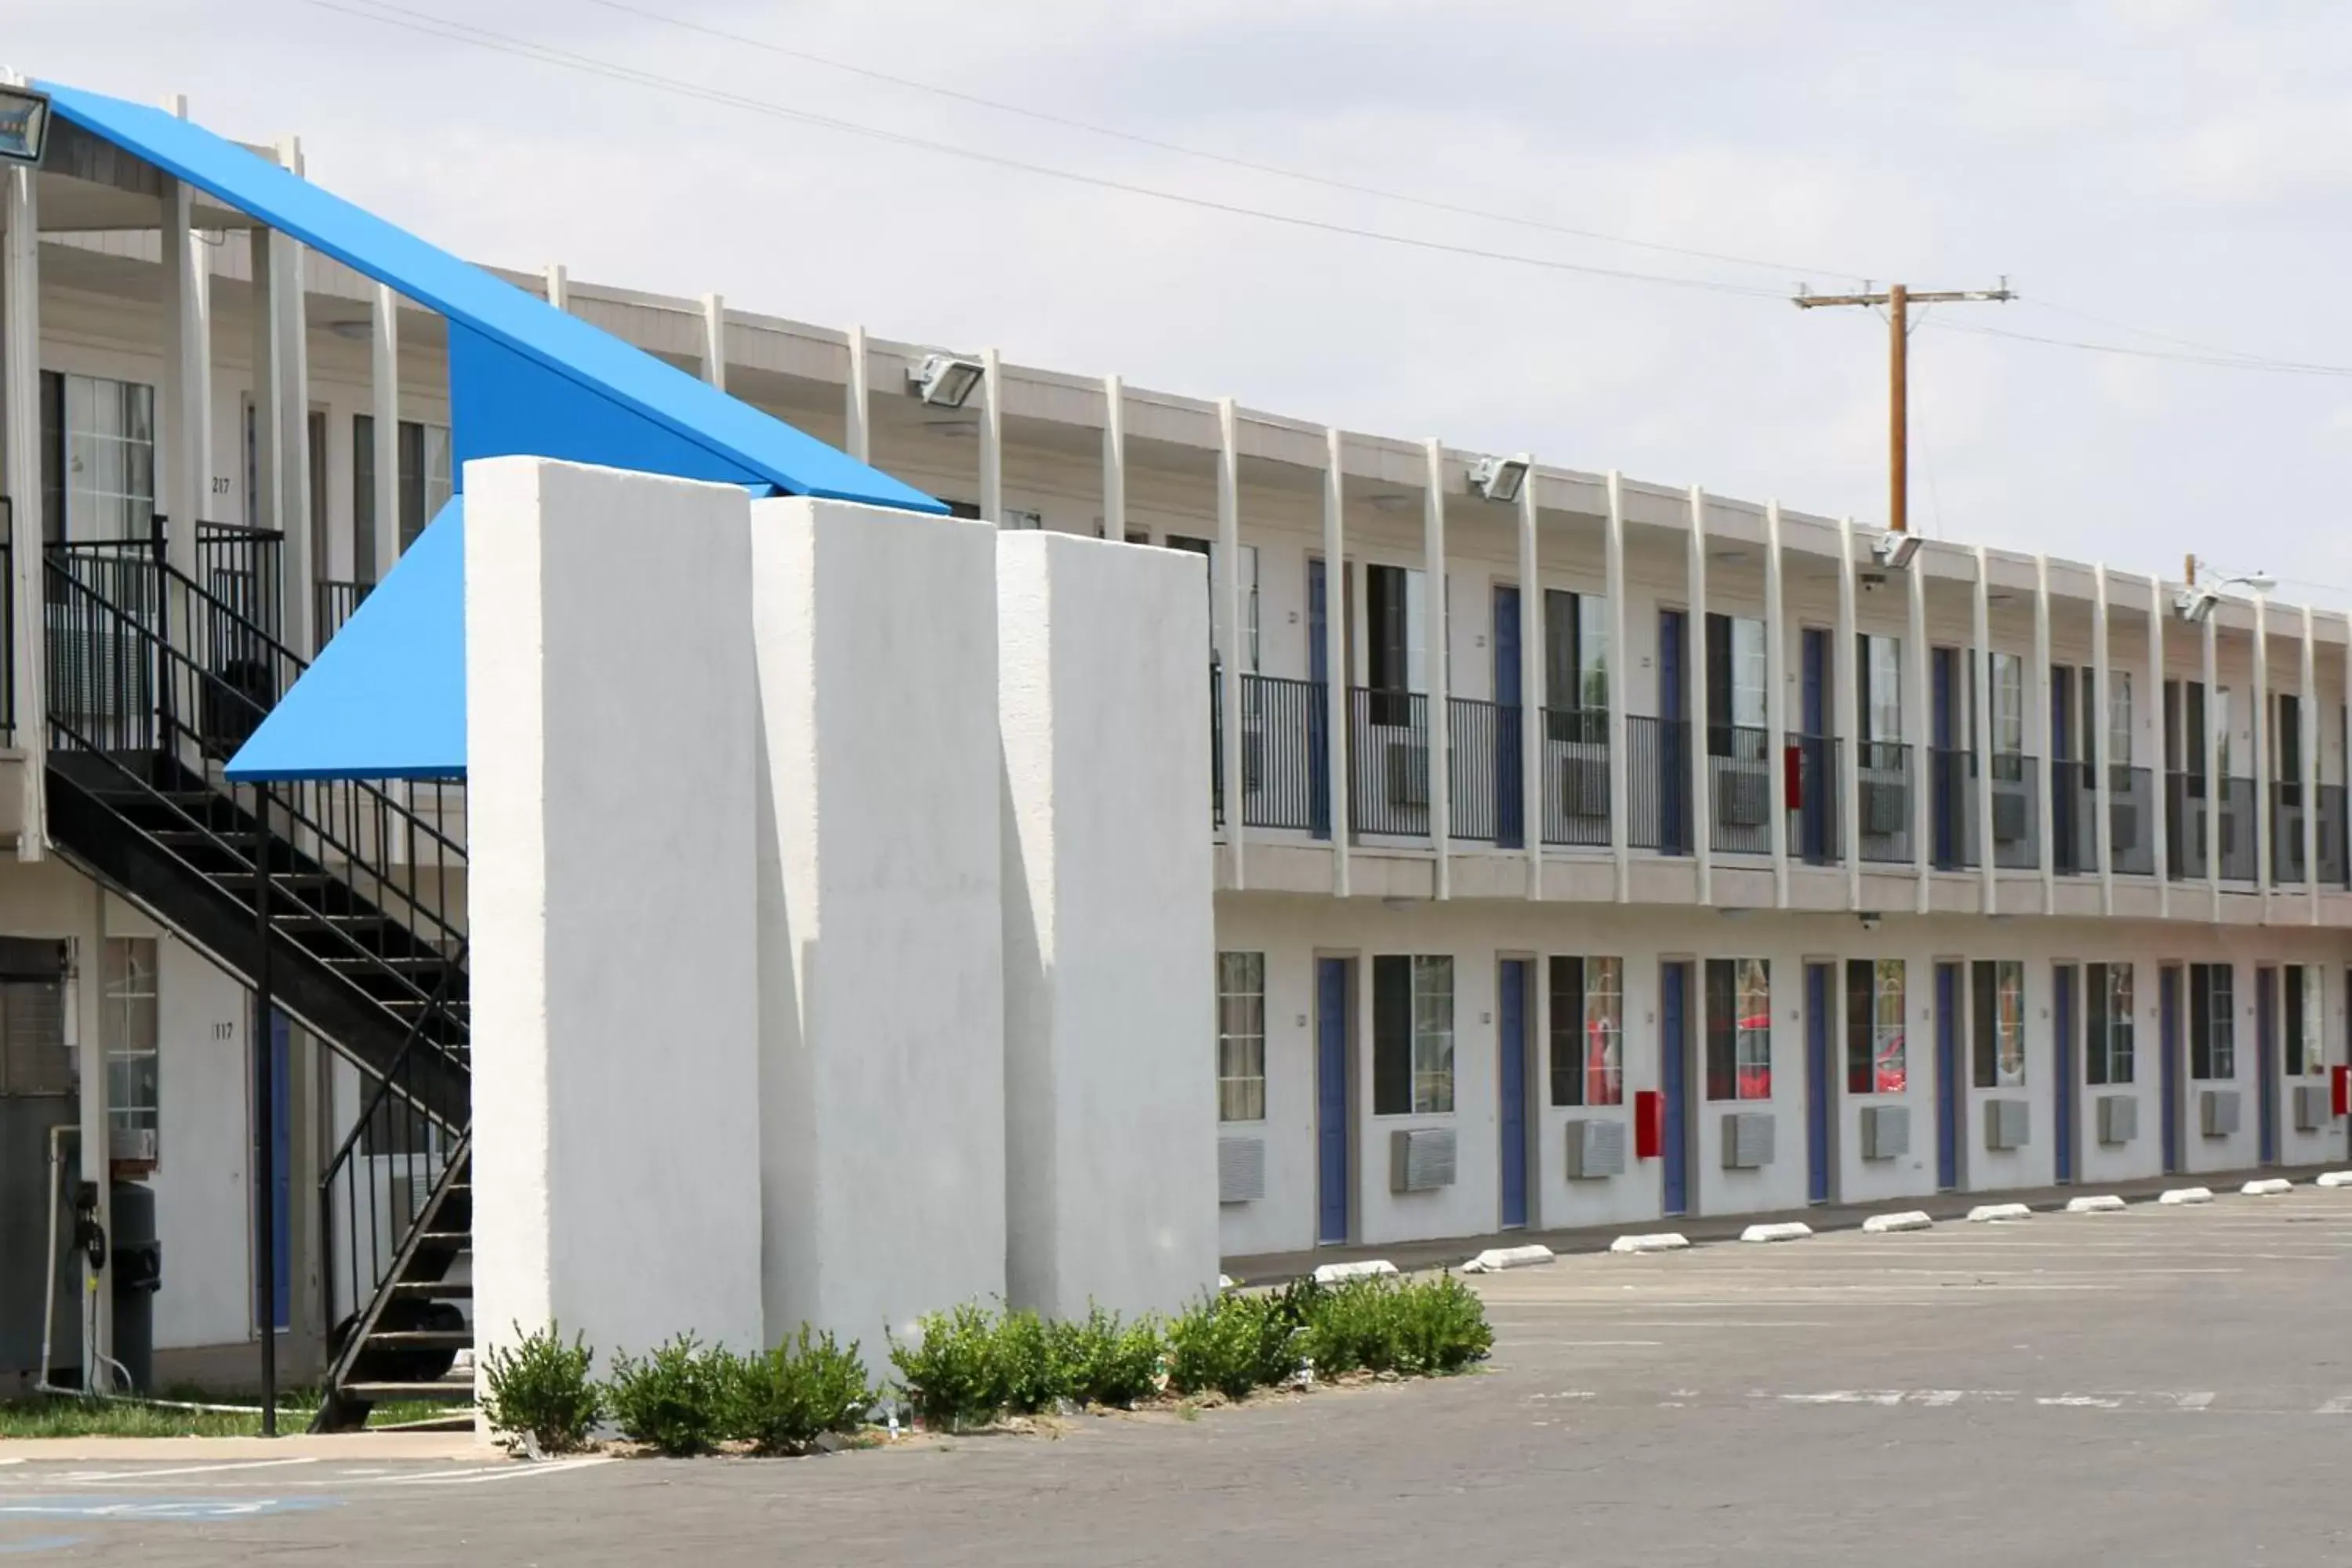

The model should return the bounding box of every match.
[466,459,764,1354]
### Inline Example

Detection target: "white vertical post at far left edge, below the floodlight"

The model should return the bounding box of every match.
[0,108,49,860]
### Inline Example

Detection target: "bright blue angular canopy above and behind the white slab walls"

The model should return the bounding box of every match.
[40,82,948,781]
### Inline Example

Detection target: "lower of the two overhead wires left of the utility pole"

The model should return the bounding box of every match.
[303,0,1780,299]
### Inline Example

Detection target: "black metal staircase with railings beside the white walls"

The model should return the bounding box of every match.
[42,543,473,1429]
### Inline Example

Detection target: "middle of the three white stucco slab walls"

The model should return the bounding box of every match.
[750,499,1007,1366]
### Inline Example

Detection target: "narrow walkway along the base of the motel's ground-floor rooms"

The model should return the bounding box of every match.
[1225,1166,2343,1286]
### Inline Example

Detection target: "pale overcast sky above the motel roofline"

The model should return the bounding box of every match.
[18,0,2352,607]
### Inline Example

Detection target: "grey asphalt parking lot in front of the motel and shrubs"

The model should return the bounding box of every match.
[13,1187,2352,1568]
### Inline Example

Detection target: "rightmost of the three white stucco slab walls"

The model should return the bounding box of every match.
[997,534,1218,1316]
